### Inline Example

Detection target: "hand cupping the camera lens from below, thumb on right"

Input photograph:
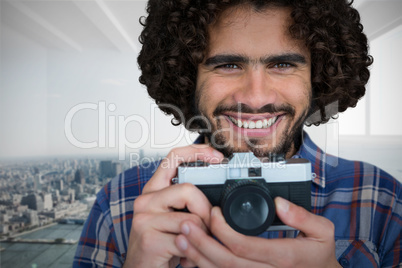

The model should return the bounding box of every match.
[175,198,341,268]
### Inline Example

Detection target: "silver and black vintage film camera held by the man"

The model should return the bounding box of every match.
[173,152,312,235]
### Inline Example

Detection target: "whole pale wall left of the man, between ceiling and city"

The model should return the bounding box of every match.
[0,26,195,158]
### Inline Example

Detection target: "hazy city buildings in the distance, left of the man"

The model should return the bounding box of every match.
[0,152,154,238]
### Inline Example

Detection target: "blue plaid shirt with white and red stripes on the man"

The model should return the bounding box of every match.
[73,134,402,267]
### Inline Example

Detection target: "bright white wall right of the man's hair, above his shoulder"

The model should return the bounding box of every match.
[307,23,402,181]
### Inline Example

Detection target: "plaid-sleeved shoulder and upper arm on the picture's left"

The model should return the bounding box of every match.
[74,162,159,267]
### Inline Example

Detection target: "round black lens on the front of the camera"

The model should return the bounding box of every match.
[221,180,275,235]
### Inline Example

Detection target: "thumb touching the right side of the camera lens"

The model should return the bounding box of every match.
[275,197,335,241]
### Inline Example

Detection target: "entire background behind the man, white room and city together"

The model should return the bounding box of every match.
[0,0,402,267]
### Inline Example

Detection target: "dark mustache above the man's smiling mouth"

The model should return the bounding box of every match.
[213,103,296,116]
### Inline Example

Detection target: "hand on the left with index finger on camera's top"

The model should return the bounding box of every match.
[124,145,223,267]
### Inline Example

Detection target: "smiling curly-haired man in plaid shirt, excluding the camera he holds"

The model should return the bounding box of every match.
[74,0,402,267]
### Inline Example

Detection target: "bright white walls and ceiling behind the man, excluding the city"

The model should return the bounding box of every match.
[0,0,402,179]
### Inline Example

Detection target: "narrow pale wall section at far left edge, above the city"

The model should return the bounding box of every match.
[0,26,48,156]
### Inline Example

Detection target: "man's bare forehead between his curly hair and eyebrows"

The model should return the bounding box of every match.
[207,6,309,56]
